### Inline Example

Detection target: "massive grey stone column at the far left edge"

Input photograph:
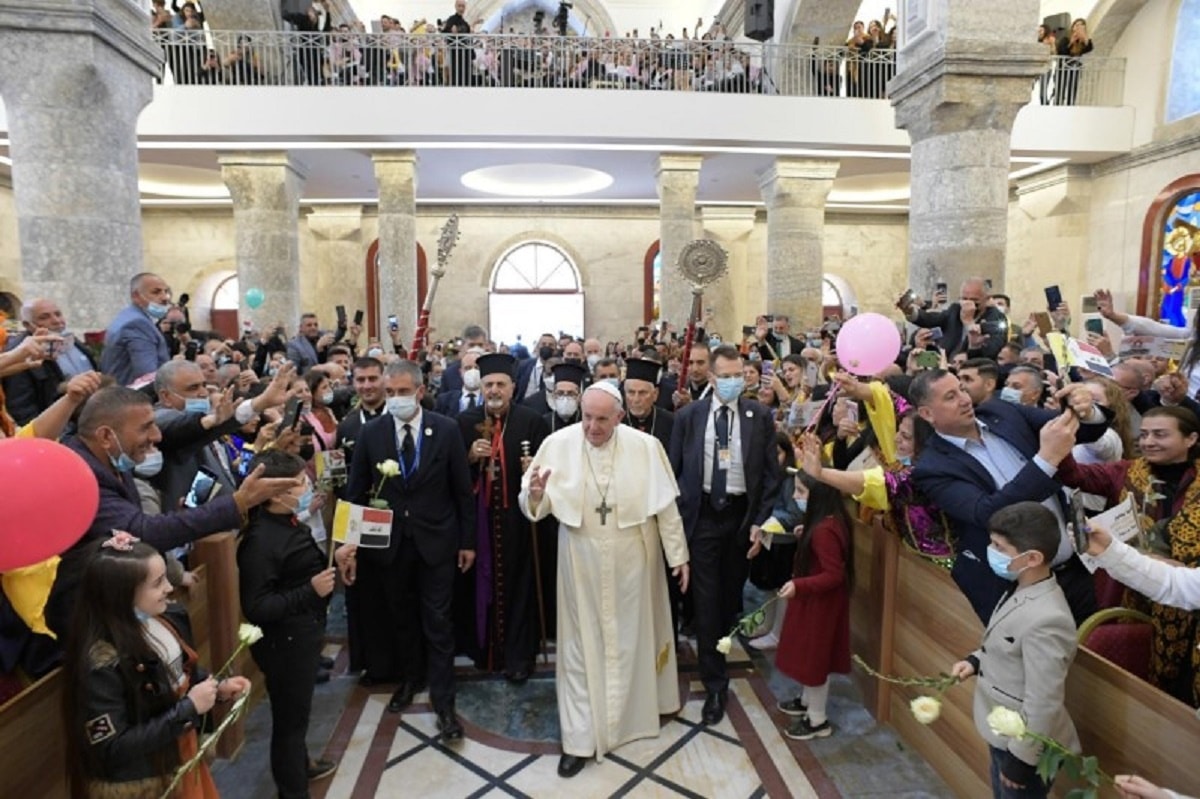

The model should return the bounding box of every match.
[0,0,162,331]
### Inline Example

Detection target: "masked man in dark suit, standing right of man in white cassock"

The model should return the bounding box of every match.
[670,346,781,725]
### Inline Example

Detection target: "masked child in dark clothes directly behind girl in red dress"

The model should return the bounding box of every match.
[746,433,809,650]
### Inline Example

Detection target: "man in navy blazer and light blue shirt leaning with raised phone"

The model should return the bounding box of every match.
[908,370,1108,624]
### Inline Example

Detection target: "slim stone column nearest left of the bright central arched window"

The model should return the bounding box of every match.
[371,150,420,342]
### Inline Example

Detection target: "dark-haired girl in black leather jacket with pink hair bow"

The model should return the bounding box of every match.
[62,533,250,799]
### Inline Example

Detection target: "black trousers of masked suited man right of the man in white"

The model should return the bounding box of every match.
[688,494,750,691]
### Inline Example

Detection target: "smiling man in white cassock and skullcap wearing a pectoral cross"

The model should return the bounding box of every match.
[521,383,689,777]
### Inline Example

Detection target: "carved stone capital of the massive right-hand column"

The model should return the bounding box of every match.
[888,40,1049,142]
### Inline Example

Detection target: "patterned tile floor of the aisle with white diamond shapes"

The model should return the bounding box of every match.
[214,587,953,799]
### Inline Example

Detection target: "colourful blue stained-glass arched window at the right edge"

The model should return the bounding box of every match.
[1138,174,1200,328]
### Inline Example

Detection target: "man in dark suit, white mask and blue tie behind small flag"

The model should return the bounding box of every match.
[346,361,475,741]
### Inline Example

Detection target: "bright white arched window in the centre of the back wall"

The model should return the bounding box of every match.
[487,241,583,344]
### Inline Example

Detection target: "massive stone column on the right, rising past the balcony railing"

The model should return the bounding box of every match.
[888,0,1048,296]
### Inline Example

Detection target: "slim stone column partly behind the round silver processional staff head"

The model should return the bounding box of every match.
[656,155,704,330]
